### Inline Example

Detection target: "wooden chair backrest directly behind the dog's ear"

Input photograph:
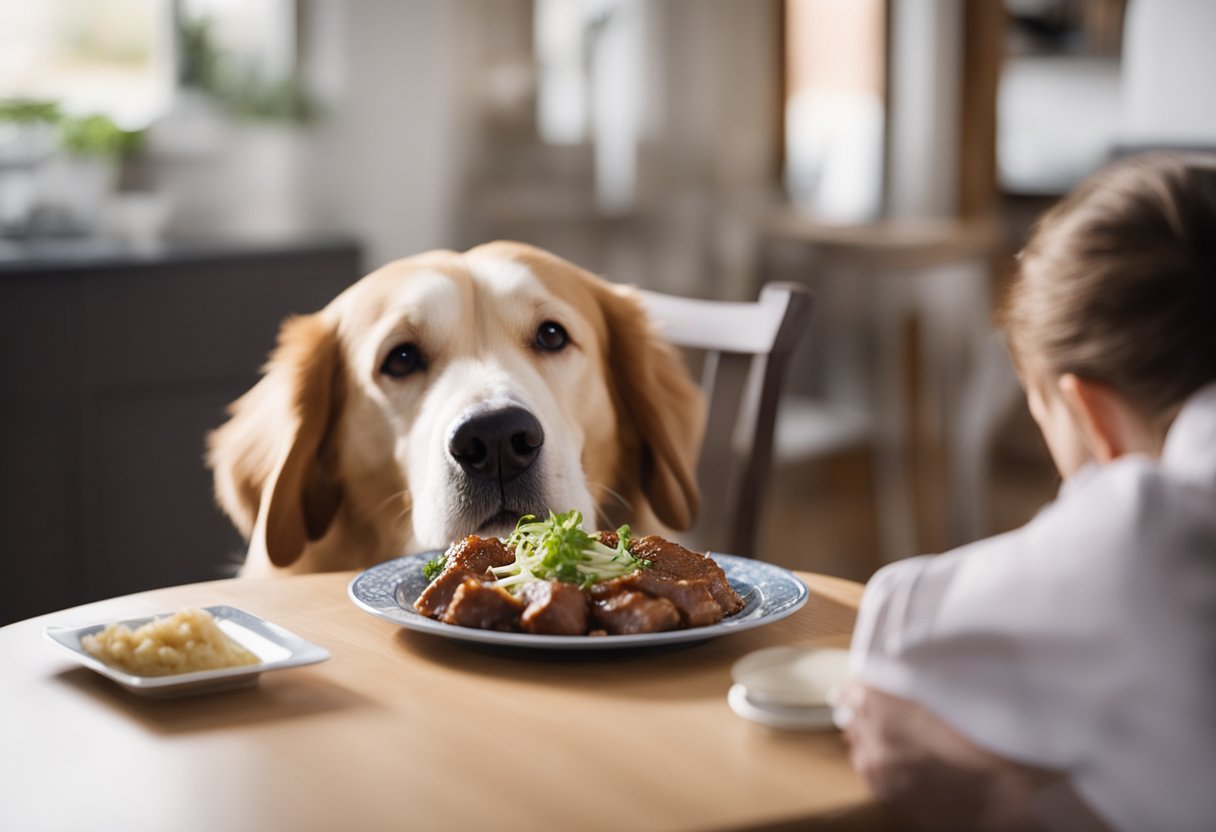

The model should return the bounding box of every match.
[641,283,811,557]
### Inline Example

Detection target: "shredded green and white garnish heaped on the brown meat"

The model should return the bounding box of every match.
[490,510,651,591]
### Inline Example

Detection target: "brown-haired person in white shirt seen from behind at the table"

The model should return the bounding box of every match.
[837,154,1216,832]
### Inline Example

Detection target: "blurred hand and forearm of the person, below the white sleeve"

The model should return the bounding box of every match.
[837,682,1059,832]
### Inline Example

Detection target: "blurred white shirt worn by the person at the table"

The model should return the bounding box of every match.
[851,384,1216,832]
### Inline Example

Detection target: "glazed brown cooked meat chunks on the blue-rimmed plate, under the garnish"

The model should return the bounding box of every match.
[413,532,743,635]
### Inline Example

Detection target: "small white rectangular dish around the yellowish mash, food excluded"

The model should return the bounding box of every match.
[43,606,330,698]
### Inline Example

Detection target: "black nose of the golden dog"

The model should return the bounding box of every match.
[447,407,545,482]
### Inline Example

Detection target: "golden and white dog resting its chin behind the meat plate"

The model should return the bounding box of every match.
[208,242,704,574]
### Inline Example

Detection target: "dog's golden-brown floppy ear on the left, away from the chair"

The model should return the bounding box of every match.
[208,313,344,567]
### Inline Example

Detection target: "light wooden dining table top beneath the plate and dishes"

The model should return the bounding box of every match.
[0,573,899,832]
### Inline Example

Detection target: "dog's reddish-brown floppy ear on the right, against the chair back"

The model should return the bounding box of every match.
[602,286,705,530]
